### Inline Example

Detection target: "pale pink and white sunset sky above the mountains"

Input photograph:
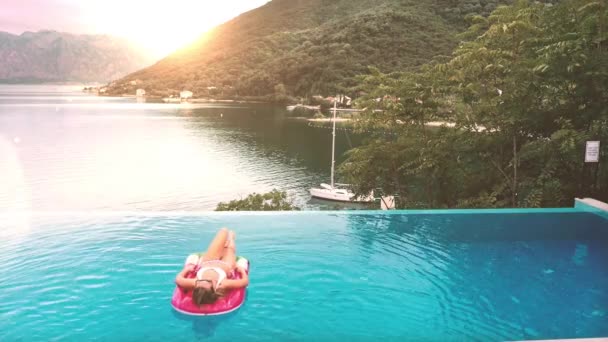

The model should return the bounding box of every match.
[0,0,269,58]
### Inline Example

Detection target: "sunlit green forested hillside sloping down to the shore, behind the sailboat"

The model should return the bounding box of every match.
[109,0,510,99]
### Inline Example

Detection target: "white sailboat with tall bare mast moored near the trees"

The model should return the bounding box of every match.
[310,101,374,203]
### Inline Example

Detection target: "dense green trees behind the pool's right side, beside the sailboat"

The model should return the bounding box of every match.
[341,0,608,207]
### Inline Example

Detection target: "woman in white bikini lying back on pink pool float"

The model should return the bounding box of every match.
[175,228,249,305]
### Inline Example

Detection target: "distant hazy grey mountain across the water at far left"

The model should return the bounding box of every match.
[0,31,152,82]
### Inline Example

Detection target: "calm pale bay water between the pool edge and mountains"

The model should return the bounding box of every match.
[0,85,366,211]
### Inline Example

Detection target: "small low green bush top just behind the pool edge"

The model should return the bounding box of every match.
[215,189,298,211]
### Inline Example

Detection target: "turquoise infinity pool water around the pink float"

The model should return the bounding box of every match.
[0,209,608,341]
